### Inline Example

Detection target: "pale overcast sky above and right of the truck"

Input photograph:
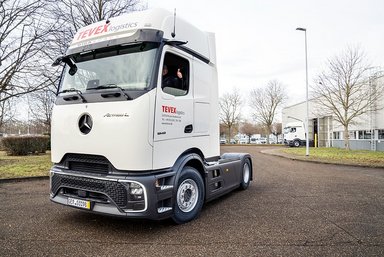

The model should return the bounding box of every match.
[147,0,384,105]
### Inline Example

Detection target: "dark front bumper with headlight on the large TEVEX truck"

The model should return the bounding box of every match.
[50,167,174,220]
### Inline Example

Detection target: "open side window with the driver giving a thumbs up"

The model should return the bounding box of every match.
[161,53,189,96]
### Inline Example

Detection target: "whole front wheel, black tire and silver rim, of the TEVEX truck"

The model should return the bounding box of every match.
[172,166,205,224]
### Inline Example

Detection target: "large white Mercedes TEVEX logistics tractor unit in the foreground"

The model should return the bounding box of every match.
[50,9,253,223]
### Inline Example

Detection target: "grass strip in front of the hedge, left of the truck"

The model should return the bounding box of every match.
[0,151,52,179]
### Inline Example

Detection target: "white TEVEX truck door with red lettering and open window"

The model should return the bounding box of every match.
[154,46,194,142]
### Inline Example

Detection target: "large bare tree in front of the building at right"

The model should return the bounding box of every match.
[312,47,384,150]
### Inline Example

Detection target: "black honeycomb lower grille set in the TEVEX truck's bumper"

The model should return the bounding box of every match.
[51,173,127,209]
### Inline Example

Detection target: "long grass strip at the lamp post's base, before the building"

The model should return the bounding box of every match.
[281,147,384,167]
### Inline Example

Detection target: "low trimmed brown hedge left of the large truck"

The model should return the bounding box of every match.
[2,136,50,155]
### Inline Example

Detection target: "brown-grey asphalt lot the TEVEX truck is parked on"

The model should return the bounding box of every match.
[0,146,384,256]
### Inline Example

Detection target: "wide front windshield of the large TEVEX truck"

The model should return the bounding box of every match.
[60,43,158,92]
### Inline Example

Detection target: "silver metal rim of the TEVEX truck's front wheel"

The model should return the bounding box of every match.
[177,179,199,212]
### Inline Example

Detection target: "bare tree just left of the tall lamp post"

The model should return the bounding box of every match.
[250,80,286,144]
